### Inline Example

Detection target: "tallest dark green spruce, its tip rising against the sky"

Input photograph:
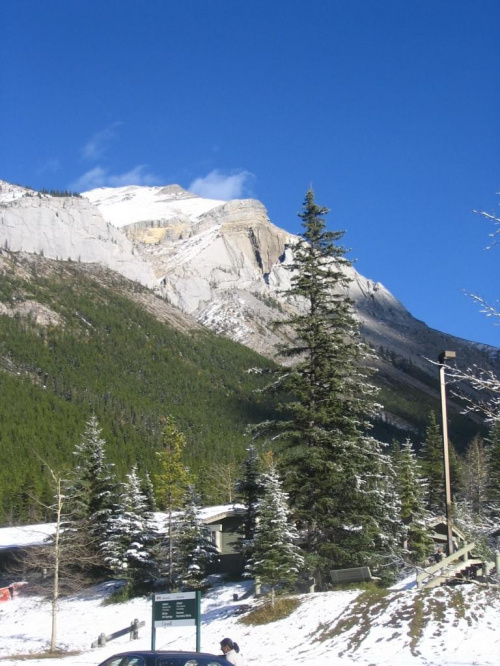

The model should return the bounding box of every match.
[257,190,393,584]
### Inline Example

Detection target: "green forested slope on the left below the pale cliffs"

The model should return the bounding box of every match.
[0,250,278,523]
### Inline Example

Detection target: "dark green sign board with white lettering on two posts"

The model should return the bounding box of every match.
[151,590,201,652]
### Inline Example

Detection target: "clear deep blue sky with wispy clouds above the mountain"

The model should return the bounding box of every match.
[0,0,500,346]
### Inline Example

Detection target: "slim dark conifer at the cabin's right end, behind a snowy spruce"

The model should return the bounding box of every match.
[236,444,264,559]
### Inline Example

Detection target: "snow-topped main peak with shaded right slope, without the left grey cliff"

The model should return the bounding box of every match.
[80,186,500,436]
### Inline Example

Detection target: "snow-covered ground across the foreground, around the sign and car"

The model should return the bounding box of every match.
[0,582,500,666]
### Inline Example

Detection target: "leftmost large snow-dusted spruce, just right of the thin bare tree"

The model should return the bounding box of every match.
[61,416,117,573]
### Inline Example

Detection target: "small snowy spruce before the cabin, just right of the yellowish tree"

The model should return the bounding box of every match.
[174,485,219,590]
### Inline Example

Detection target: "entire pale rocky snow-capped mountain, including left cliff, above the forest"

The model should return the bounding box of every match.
[0,181,497,389]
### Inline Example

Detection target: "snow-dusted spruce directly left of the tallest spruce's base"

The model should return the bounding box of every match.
[246,464,304,604]
